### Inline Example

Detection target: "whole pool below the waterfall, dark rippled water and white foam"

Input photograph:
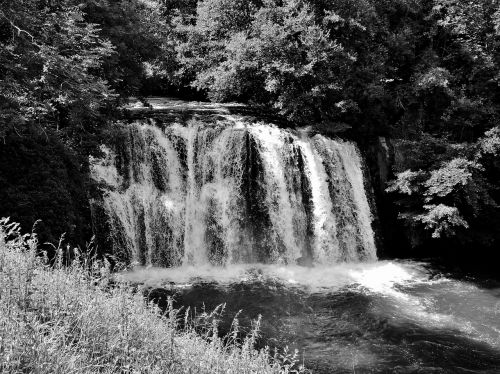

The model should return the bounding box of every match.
[124,261,500,373]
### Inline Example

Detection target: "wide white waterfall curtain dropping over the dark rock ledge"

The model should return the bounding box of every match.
[92,119,376,266]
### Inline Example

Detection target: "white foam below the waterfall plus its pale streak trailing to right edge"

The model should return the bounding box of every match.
[119,261,500,348]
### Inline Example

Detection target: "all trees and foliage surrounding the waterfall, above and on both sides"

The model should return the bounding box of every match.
[0,0,500,258]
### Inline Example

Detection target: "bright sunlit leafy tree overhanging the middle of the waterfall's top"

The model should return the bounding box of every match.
[177,0,355,122]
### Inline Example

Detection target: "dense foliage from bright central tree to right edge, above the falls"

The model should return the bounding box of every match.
[171,0,498,136]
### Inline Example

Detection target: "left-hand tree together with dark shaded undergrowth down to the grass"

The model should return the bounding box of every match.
[0,0,116,245]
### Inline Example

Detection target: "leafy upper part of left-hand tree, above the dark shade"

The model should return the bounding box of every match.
[0,0,114,142]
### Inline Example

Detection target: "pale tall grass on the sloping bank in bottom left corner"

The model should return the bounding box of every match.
[0,220,304,374]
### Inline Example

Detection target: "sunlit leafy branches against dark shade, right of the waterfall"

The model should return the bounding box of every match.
[386,138,498,238]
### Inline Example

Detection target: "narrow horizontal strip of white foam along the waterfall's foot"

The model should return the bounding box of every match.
[120,261,418,296]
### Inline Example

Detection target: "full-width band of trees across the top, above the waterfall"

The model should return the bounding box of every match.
[0,0,500,137]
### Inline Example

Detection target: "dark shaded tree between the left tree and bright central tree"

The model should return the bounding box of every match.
[83,0,177,96]
